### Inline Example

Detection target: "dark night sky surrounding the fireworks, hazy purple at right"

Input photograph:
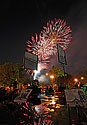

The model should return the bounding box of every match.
[0,0,87,74]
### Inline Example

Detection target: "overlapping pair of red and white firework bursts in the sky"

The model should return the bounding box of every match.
[27,19,72,63]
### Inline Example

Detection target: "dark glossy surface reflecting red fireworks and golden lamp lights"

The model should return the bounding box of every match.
[17,93,64,125]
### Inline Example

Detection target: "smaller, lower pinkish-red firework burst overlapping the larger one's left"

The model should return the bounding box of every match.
[26,34,51,63]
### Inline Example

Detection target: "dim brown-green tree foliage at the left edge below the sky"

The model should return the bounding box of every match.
[0,62,25,86]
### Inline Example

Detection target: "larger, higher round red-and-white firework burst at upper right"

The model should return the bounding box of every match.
[41,19,72,50]
